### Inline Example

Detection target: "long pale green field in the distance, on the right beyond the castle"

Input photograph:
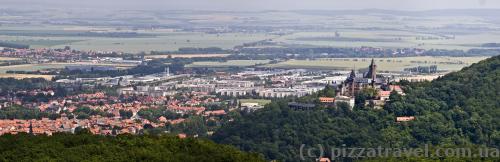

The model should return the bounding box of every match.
[276,29,500,50]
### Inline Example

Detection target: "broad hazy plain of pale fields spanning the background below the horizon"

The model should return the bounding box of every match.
[0,10,500,53]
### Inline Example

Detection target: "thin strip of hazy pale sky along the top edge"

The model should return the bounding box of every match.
[0,0,500,11]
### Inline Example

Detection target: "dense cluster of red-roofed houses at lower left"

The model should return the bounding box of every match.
[0,85,226,135]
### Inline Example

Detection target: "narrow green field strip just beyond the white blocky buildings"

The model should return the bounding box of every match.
[187,60,270,67]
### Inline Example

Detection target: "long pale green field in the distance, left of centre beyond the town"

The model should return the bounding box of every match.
[47,33,266,53]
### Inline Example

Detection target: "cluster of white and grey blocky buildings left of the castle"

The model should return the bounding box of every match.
[175,70,326,98]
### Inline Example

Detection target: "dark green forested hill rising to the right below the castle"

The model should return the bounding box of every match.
[213,56,500,161]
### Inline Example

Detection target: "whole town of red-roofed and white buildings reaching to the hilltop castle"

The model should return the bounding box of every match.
[0,46,434,136]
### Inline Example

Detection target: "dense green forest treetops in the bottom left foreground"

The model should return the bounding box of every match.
[0,132,264,162]
